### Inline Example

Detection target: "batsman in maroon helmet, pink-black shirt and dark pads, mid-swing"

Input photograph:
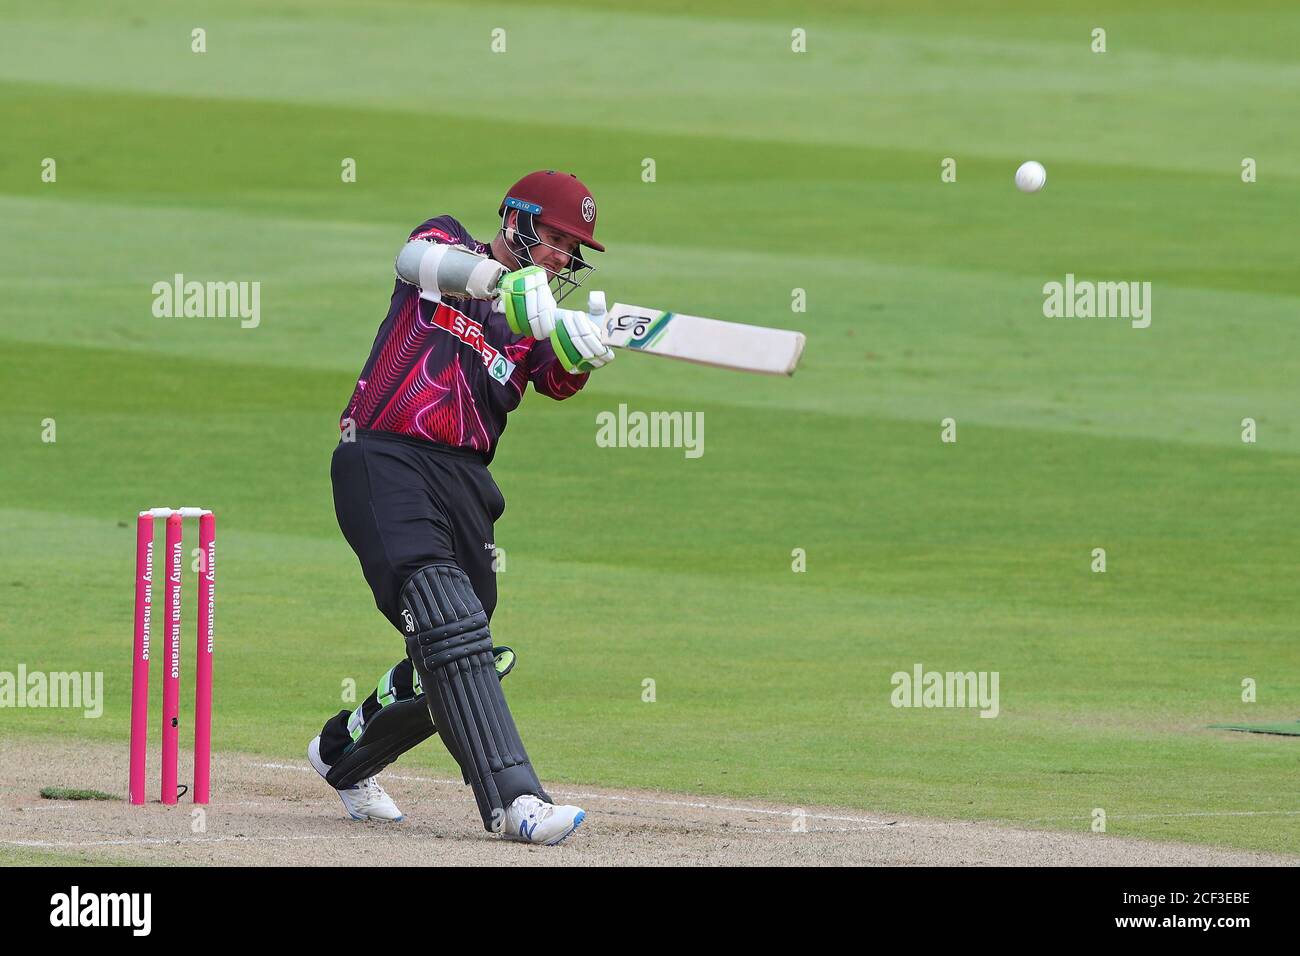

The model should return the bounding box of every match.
[307,170,614,844]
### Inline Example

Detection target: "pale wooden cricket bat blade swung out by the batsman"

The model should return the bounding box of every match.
[605,303,803,375]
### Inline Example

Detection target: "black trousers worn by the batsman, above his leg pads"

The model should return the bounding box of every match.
[321,432,506,763]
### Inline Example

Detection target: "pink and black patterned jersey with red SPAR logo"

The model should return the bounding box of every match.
[339,216,589,460]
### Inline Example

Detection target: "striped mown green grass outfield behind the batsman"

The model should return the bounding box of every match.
[0,0,1300,860]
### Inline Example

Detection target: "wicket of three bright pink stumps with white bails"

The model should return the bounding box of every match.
[129,507,217,805]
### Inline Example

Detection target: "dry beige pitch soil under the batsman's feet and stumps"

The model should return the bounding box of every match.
[0,740,1300,866]
